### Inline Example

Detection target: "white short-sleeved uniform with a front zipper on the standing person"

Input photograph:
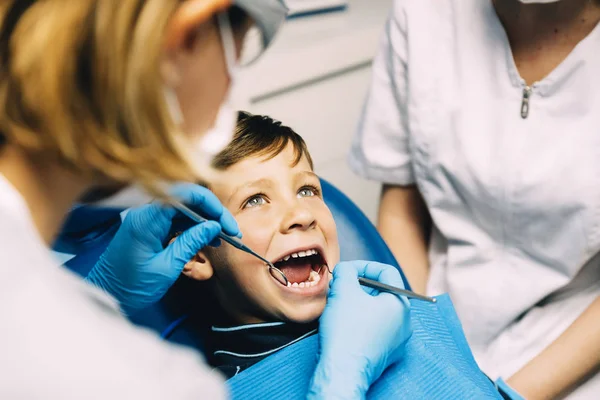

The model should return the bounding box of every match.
[350,0,600,398]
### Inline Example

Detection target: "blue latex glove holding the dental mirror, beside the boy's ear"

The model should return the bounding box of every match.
[86,184,241,314]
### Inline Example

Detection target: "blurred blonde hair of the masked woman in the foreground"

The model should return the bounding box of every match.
[0,0,202,191]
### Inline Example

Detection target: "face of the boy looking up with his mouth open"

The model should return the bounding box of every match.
[197,144,339,323]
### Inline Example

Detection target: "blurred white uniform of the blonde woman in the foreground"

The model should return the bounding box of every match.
[0,175,225,400]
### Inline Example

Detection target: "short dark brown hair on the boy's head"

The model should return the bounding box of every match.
[212,111,313,170]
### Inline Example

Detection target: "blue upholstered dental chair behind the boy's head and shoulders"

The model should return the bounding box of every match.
[53,179,408,348]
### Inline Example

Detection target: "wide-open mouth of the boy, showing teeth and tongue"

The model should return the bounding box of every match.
[273,247,327,288]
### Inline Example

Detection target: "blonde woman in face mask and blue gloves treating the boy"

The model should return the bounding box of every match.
[0,0,410,399]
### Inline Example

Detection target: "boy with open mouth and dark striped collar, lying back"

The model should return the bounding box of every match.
[169,113,339,377]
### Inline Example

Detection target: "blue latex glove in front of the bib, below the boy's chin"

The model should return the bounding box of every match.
[308,261,412,399]
